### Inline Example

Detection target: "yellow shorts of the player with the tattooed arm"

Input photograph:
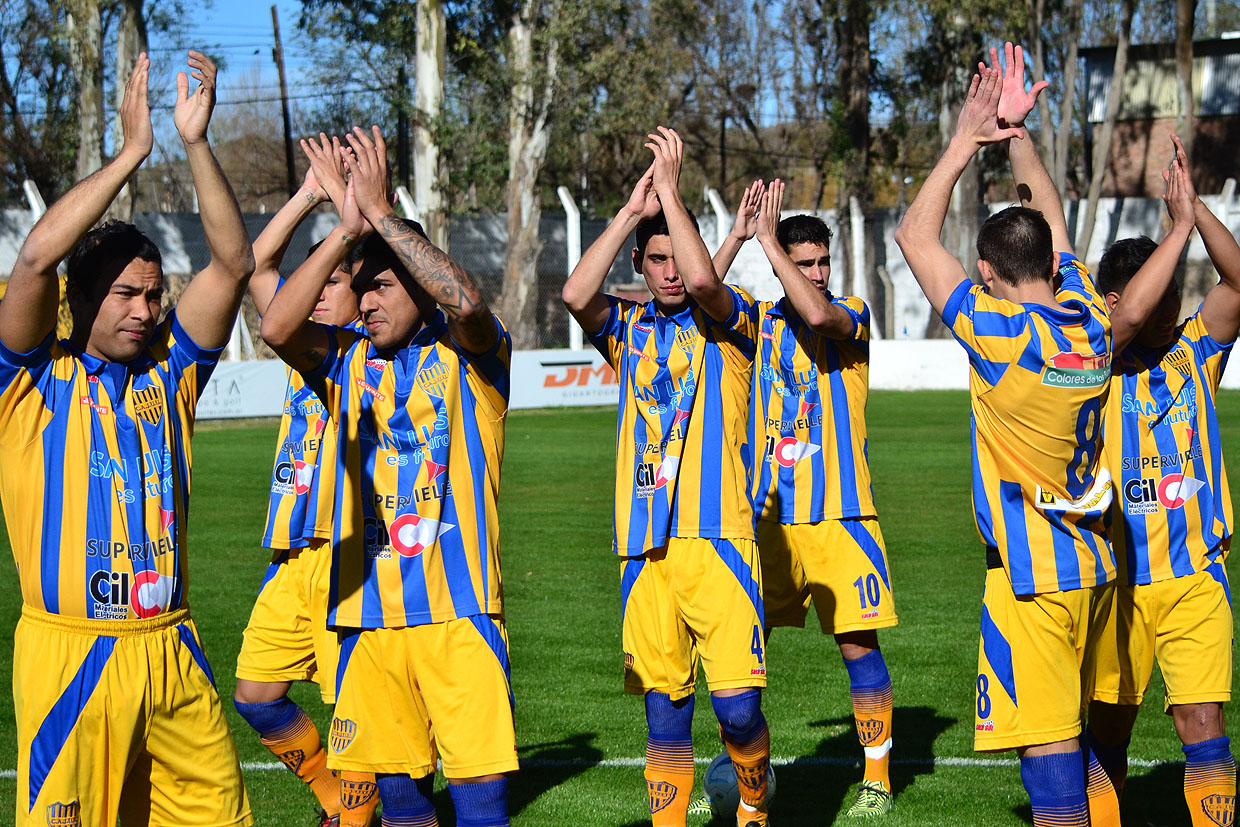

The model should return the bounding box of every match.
[327,615,517,779]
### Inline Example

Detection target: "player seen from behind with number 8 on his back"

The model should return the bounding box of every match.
[895,43,1117,825]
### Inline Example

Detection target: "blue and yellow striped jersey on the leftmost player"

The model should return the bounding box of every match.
[0,315,221,622]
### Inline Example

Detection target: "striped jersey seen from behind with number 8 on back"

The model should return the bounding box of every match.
[942,254,1115,594]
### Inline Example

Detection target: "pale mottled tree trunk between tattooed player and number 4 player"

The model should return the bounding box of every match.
[500,0,559,348]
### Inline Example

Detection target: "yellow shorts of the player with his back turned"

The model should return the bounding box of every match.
[973,568,1105,753]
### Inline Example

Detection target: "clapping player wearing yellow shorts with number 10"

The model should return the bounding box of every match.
[715,180,898,816]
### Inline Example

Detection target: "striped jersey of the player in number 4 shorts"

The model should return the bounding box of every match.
[590,285,758,557]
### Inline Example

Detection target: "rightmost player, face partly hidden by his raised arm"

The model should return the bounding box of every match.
[1087,136,1240,826]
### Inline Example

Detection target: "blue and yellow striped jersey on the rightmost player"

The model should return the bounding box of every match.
[1102,310,1234,585]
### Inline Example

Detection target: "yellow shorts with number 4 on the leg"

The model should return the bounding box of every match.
[620,537,766,701]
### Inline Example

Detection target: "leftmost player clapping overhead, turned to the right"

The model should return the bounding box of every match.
[0,51,254,827]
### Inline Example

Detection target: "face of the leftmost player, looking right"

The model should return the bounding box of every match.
[74,258,164,362]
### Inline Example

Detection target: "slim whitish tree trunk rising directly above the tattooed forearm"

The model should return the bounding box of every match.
[413,0,448,250]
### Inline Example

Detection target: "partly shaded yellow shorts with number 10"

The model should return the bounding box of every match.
[758,518,899,635]
